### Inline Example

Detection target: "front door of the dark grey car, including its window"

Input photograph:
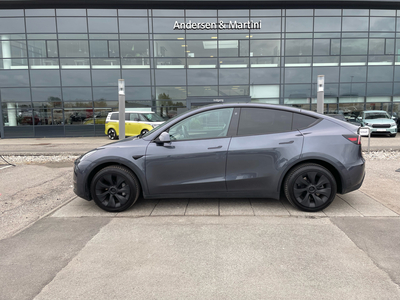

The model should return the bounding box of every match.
[145,108,233,196]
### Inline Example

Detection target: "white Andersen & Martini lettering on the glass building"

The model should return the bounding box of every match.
[174,20,261,30]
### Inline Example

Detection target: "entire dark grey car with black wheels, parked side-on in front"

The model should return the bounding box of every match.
[74,103,365,212]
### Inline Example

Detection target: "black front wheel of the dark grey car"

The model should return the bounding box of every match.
[90,166,140,212]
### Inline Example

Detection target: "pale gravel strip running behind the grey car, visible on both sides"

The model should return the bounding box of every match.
[0,150,400,164]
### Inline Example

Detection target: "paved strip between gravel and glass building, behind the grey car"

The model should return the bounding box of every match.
[0,133,400,155]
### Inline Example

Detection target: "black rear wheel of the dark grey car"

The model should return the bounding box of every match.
[284,163,337,212]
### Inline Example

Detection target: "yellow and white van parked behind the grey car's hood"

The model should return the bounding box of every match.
[105,111,164,140]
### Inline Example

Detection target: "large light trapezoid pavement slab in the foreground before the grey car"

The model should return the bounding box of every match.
[35,216,400,300]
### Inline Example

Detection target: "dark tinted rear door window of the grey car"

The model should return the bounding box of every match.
[238,108,292,135]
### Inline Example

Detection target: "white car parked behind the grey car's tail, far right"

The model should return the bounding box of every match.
[357,110,397,137]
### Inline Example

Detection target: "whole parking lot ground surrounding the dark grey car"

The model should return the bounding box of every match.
[0,137,400,300]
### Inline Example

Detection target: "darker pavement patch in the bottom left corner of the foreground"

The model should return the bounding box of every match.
[0,218,110,300]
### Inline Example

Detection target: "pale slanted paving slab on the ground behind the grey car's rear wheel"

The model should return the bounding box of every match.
[338,191,398,217]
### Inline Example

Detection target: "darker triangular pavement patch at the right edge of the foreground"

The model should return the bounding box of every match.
[332,217,400,286]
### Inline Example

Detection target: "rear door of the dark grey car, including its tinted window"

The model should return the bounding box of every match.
[226,108,303,197]
